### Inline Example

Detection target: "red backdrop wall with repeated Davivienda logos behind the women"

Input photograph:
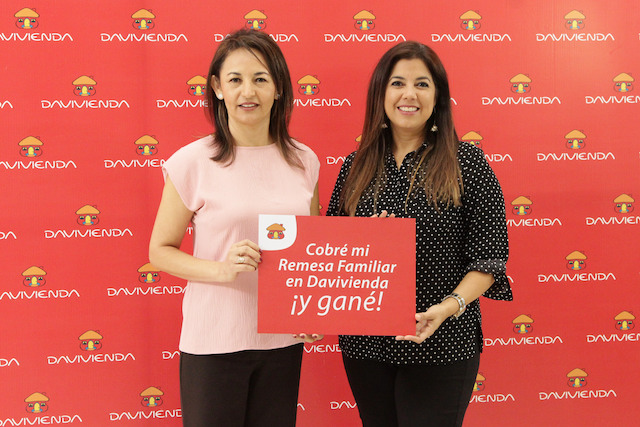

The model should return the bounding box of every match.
[0,0,640,426]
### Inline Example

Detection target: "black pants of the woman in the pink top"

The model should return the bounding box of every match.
[180,344,303,427]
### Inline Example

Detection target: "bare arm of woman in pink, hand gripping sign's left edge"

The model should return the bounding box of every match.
[149,176,260,282]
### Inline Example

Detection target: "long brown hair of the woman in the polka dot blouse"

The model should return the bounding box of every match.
[339,41,463,216]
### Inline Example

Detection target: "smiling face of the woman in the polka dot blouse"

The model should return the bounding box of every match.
[384,58,436,132]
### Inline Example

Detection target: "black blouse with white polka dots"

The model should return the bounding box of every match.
[327,142,513,365]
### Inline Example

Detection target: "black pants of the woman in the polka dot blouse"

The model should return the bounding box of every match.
[342,353,480,427]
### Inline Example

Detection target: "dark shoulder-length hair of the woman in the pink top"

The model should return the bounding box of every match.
[205,29,302,167]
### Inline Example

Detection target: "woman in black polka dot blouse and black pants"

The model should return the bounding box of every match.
[327,42,512,427]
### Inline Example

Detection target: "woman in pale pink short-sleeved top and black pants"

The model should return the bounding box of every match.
[149,30,321,427]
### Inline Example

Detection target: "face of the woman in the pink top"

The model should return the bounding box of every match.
[212,49,276,128]
